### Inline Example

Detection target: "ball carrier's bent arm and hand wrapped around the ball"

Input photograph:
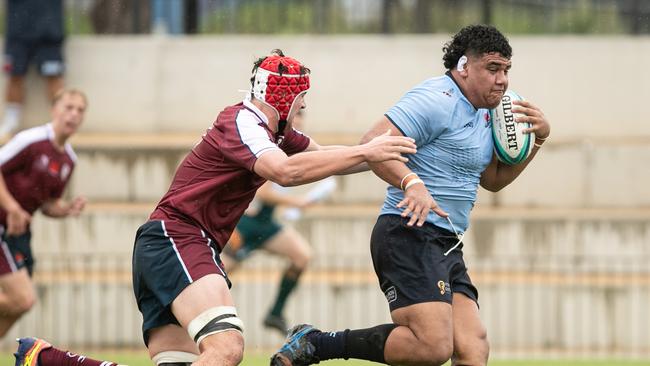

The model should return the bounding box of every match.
[481,100,551,192]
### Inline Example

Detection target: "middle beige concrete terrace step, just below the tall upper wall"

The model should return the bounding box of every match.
[64,140,650,208]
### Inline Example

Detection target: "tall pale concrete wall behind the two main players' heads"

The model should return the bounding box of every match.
[7,35,650,140]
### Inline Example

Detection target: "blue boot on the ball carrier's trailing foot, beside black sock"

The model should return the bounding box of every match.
[271,324,320,366]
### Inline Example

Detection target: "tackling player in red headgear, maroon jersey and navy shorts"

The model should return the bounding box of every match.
[126,50,415,366]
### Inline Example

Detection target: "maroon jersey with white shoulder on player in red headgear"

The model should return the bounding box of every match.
[150,101,310,249]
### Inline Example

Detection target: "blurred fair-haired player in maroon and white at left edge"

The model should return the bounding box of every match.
[0,89,87,337]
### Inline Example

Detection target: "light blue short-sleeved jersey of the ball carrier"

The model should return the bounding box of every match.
[381,75,493,232]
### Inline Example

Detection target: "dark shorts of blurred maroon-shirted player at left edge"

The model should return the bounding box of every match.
[0,226,34,276]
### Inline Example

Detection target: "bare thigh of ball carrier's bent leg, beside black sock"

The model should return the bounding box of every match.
[385,301,453,364]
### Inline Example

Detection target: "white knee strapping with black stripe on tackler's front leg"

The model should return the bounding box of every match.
[187,306,244,344]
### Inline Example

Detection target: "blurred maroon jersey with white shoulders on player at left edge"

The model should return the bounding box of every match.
[0,123,77,226]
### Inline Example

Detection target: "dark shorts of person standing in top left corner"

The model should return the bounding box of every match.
[4,39,65,76]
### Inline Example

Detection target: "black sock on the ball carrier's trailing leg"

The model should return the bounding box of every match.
[308,324,397,363]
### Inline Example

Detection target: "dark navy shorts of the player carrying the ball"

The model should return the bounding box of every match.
[370,215,478,311]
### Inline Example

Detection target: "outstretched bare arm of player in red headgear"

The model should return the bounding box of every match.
[253,131,416,186]
